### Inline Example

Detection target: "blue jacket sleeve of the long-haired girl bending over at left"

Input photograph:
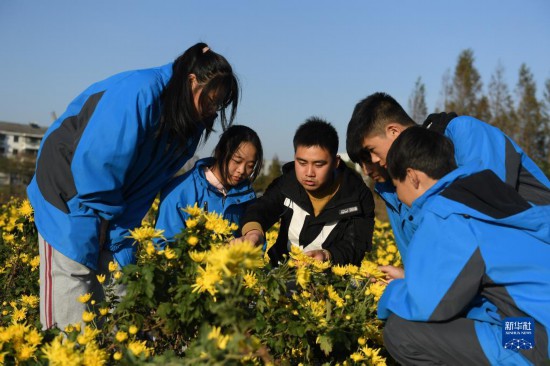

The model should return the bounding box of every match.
[71,79,158,220]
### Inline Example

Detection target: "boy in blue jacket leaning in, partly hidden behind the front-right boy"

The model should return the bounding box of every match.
[346,93,550,259]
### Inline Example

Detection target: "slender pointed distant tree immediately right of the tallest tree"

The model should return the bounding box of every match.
[488,62,519,140]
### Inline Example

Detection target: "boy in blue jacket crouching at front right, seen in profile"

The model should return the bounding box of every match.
[378,127,550,365]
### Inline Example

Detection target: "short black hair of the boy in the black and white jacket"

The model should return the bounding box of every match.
[293,117,338,157]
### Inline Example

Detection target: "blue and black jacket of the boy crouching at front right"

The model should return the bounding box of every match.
[378,166,550,365]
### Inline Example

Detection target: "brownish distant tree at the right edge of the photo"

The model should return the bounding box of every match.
[516,64,548,165]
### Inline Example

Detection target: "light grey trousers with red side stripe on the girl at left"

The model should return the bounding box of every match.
[38,234,125,330]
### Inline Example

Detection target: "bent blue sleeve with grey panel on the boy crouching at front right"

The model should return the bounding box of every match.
[378,213,484,321]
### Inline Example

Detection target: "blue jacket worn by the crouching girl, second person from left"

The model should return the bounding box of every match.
[156,158,256,241]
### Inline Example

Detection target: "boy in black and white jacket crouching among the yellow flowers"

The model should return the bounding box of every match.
[237,117,374,265]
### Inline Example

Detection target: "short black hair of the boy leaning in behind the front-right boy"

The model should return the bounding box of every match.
[346,92,416,163]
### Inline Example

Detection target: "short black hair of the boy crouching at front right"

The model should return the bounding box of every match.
[386,126,462,182]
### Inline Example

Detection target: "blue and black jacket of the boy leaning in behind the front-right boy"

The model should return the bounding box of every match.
[375,113,550,259]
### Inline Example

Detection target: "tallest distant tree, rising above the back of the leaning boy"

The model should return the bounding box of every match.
[445,49,490,120]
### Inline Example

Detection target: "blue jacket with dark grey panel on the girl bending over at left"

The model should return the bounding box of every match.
[27,64,202,269]
